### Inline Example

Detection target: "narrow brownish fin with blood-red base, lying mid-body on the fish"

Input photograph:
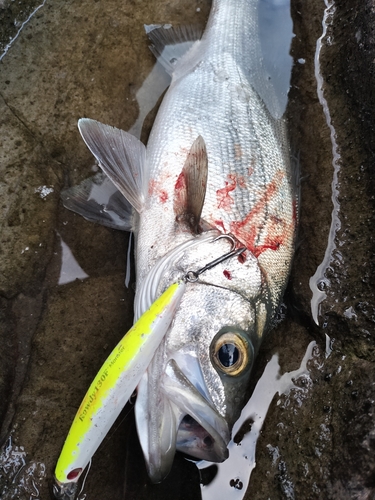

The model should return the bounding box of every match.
[174,136,208,234]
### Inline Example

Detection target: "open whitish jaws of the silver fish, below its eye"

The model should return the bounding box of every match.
[135,356,230,483]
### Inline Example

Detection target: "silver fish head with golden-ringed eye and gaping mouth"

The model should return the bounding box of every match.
[136,236,268,482]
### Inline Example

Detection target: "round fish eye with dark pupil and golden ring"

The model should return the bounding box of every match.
[211,332,249,376]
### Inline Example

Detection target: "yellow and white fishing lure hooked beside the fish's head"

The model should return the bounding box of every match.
[55,281,186,486]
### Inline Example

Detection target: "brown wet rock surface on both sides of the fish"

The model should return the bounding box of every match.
[0,0,375,500]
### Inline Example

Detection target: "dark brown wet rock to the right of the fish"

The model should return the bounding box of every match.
[247,1,375,499]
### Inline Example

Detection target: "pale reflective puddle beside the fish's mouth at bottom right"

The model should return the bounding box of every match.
[197,342,316,500]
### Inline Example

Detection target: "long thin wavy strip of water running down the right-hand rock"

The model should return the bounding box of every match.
[309,0,341,325]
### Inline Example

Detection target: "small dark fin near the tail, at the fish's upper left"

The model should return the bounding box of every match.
[145,24,203,75]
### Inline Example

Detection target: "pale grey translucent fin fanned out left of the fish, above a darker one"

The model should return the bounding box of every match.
[78,118,146,213]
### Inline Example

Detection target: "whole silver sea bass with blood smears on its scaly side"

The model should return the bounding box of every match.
[64,0,296,482]
